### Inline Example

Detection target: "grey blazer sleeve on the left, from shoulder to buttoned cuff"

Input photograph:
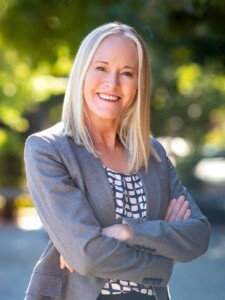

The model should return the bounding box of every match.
[25,135,173,286]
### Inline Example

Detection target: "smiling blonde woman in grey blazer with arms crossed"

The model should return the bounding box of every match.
[25,23,209,300]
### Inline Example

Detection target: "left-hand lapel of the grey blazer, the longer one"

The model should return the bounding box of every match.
[70,140,115,227]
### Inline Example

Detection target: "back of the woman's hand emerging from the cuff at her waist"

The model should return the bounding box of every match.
[102,224,133,241]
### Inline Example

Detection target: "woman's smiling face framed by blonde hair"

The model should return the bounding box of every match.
[84,35,138,125]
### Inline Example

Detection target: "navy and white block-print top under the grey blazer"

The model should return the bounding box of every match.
[101,166,154,295]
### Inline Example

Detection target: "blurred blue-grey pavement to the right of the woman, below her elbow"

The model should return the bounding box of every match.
[170,224,225,300]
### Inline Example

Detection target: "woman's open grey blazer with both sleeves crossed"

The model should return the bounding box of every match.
[25,123,210,300]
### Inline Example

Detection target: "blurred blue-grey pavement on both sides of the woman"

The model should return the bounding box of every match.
[0,226,225,300]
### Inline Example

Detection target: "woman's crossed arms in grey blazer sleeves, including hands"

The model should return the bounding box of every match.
[25,136,209,286]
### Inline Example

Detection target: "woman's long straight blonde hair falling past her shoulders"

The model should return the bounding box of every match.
[62,22,154,172]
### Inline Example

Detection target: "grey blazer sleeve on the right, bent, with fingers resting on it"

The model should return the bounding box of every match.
[124,140,210,262]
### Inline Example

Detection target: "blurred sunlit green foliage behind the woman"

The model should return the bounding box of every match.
[0,0,225,185]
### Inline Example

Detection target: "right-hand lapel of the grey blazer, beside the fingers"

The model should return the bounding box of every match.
[139,159,161,220]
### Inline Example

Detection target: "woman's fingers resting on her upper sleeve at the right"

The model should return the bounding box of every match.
[164,196,191,222]
